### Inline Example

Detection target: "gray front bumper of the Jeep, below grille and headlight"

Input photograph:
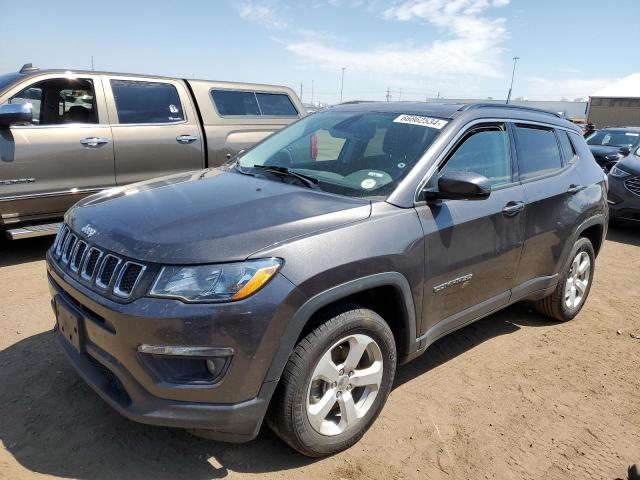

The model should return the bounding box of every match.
[47,251,304,441]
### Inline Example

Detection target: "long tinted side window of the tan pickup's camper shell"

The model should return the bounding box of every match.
[211,90,298,117]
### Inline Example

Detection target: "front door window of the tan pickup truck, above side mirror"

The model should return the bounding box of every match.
[9,78,98,125]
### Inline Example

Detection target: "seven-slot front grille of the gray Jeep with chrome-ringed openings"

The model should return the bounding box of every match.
[51,224,146,299]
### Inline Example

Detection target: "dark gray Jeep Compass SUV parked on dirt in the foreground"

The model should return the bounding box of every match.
[47,103,608,456]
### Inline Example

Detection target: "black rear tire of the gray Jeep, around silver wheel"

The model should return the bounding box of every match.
[535,238,596,322]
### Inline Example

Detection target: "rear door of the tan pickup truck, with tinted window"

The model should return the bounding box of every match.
[103,76,204,185]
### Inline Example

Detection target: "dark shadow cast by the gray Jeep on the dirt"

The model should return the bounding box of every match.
[0,306,548,480]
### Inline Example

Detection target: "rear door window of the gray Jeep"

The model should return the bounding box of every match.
[515,125,562,180]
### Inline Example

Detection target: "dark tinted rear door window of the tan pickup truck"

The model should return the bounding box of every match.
[111,80,184,124]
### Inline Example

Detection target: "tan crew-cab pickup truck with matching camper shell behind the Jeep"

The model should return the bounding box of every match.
[0,64,306,239]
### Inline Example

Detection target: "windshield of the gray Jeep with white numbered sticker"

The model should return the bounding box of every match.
[239,111,447,198]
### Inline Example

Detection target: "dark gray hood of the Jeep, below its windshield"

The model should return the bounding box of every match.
[66,169,371,264]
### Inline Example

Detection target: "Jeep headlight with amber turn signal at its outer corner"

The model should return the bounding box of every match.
[151,258,282,302]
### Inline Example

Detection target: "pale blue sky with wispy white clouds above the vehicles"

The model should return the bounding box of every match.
[0,0,640,103]
